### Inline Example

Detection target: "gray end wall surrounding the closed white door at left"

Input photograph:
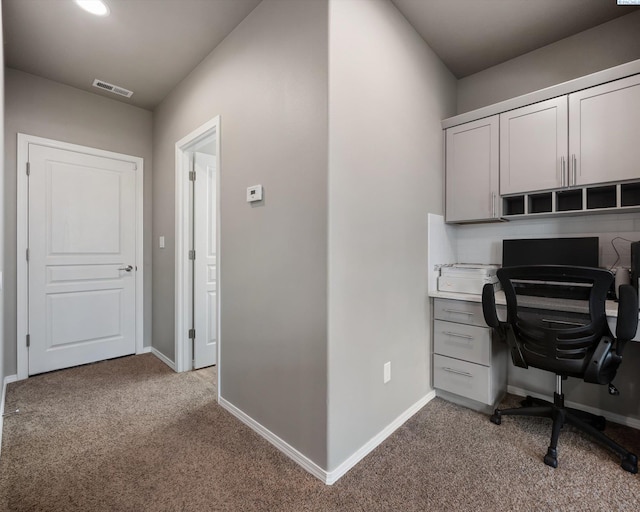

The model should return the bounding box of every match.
[3,69,152,375]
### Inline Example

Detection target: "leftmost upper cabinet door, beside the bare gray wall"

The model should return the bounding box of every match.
[445,115,499,222]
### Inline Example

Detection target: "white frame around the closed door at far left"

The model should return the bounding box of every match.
[16,133,144,380]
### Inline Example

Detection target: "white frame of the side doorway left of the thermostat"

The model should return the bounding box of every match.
[175,116,222,374]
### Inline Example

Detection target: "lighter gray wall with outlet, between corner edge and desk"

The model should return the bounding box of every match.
[328,0,456,470]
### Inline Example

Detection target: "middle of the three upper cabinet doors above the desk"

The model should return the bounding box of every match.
[500,96,568,195]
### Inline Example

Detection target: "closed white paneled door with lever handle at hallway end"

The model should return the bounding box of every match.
[28,144,137,375]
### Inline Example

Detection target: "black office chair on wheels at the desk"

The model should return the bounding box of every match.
[482,265,638,473]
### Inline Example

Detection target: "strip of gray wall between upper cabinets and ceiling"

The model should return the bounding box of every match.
[457,11,640,114]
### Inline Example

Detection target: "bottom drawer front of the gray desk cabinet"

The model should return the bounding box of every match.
[433,354,491,405]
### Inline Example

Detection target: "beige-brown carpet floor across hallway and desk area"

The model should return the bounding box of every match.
[0,354,640,512]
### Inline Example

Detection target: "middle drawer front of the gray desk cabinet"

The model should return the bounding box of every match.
[433,320,491,366]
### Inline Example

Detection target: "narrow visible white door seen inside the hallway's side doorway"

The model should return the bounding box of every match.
[193,152,218,368]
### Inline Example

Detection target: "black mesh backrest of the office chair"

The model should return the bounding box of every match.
[498,265,620,381]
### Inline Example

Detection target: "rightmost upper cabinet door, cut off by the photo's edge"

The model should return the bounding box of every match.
[569,75,640,185]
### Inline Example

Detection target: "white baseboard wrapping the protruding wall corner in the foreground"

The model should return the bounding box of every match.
[218,391,436,485]
